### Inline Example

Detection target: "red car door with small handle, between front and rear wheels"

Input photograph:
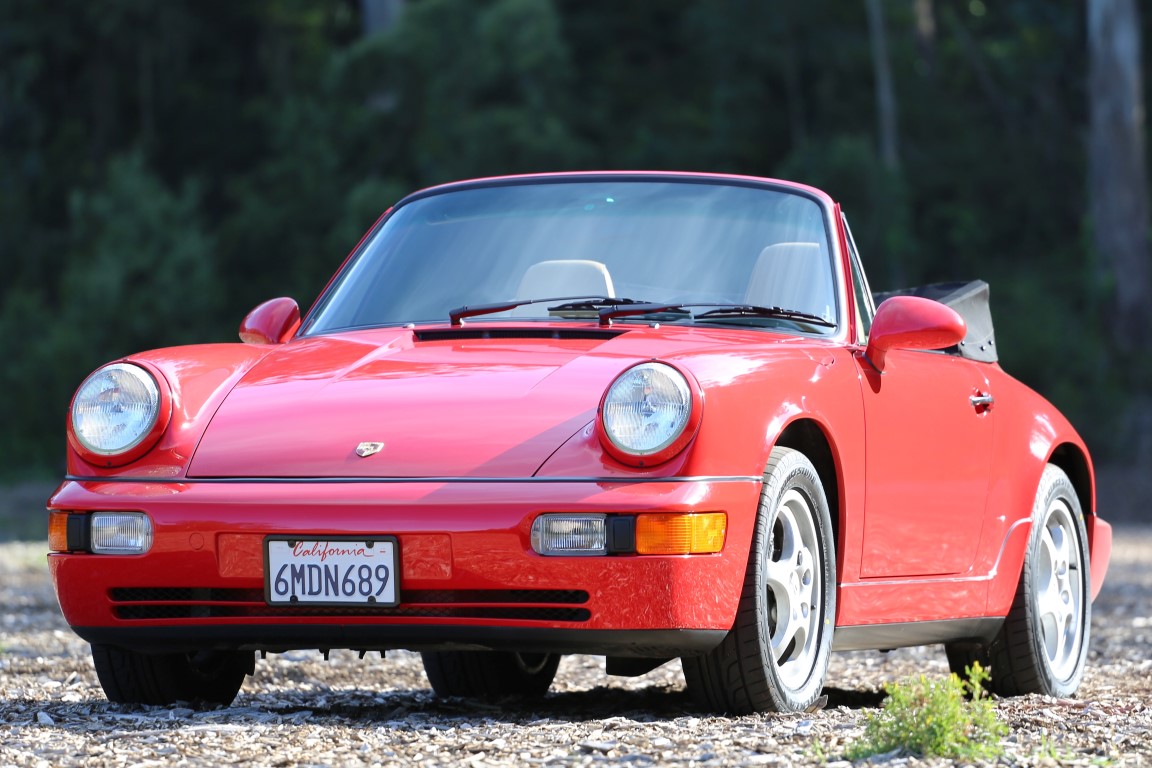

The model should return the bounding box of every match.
[858,350,994,578]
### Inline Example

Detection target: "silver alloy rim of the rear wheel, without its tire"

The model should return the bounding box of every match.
[1034,499,1085,679]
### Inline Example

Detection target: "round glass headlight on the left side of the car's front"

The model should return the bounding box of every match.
[71,363,161,456]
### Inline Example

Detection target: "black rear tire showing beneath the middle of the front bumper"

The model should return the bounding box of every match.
[420,651,560,699]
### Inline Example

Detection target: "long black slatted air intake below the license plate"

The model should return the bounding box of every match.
[108,587,592,622]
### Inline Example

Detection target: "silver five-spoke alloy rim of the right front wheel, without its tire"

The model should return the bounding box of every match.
[765,488,824,687]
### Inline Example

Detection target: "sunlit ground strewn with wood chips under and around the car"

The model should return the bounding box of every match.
[0,527,1152,768]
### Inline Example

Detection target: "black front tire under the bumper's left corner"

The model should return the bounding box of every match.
[92,645,256,705]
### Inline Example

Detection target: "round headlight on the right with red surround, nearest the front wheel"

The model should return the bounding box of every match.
[600,363,700,466]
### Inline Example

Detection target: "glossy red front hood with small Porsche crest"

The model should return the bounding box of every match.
[188,329,668,478]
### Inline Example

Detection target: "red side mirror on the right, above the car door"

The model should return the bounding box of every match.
[864,296,968,373]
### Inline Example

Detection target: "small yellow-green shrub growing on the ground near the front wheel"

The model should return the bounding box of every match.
[847,663,1008,760]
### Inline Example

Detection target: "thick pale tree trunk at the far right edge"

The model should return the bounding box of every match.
[1087,0,1152,352]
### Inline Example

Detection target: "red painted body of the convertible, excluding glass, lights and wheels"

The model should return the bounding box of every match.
[48,174,1111,709]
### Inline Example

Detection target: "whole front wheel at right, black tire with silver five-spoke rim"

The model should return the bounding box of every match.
[683,448,836,714]
